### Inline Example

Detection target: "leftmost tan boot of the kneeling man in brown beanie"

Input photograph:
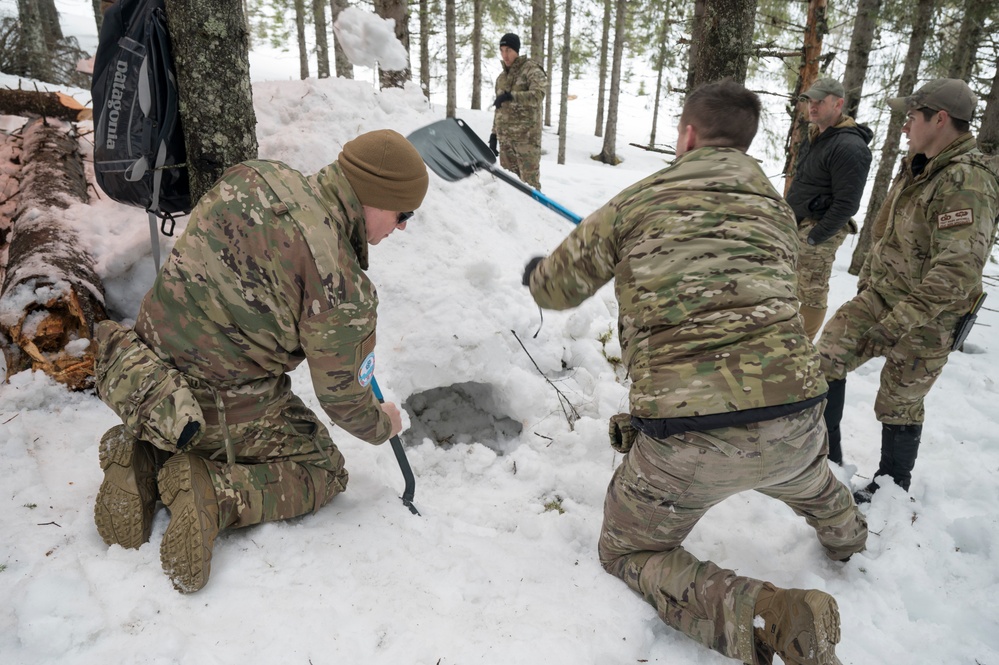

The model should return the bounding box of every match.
[94,425,157,549]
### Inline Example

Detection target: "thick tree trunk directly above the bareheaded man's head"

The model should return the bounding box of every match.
[687,0,756,93]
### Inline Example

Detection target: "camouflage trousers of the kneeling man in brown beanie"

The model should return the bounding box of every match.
[182,381,347,527]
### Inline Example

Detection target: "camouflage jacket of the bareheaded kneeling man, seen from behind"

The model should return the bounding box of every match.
[530,147,826,418]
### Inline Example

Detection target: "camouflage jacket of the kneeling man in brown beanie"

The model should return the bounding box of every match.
[135,161,391,443]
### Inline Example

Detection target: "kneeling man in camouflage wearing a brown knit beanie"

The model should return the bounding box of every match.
[95,130,428,593]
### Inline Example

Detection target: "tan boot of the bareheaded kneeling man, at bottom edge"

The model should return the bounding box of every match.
[753,583,842,665]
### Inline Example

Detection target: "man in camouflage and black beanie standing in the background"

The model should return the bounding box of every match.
[489,33,548,189]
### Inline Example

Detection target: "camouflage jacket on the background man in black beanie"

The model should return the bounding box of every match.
[493,55,548,144]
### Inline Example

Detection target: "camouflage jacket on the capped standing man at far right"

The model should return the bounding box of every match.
[861,132,999,344]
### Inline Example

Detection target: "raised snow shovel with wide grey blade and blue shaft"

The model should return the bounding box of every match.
[406,118,583,224]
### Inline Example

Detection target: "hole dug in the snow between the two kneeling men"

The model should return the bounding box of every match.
[402,382,524,455]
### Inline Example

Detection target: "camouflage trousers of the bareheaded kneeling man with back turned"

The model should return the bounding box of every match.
[599,404,867,663]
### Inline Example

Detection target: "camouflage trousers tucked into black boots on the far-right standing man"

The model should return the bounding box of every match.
[816,289,957,425]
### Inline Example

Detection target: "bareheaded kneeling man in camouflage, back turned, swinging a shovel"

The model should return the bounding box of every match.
[524,81,867,664]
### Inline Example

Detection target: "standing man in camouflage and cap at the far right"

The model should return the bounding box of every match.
[818,79,999,501]
